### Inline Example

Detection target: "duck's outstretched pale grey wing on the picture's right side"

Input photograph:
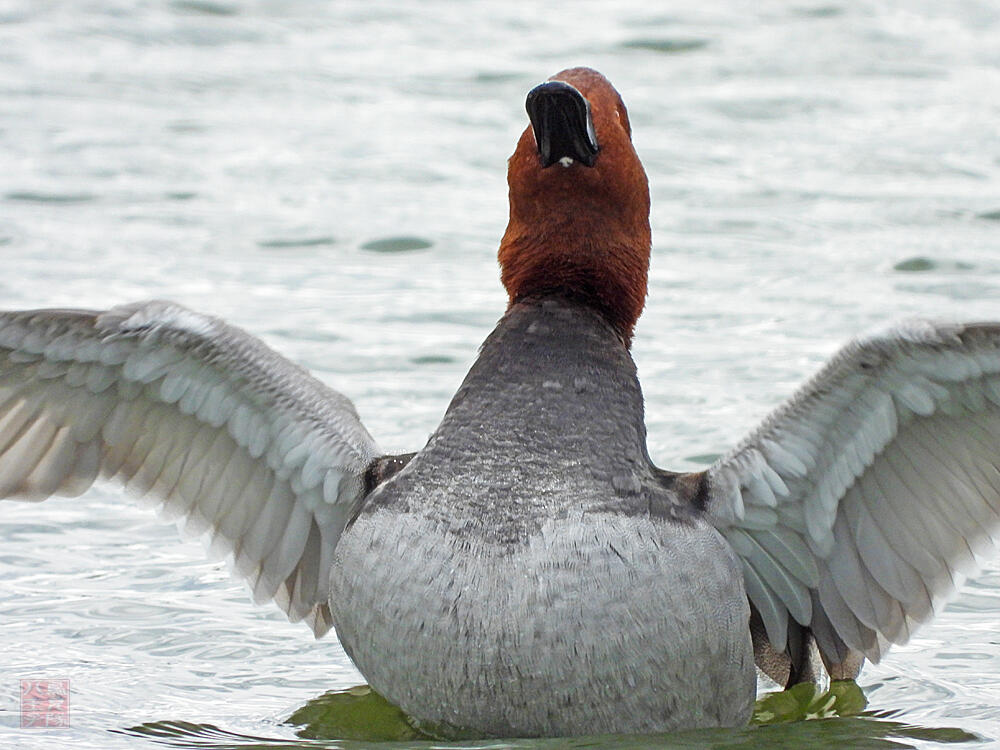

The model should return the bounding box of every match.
[704,321,1000,665]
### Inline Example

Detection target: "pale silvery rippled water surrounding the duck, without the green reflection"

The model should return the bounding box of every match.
[0,0,1000,748]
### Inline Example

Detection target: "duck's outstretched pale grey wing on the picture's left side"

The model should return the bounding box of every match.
[0,301,379,637]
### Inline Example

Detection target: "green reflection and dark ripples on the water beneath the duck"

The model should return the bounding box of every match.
[124,681,981,750]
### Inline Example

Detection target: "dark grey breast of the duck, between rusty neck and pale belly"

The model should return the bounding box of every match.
[362,299,693,544]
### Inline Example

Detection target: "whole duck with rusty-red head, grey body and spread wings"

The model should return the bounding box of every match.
[0,68,1000,737]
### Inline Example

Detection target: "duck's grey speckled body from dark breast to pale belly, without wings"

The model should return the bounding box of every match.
[330,299,755,736]
